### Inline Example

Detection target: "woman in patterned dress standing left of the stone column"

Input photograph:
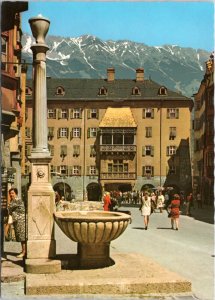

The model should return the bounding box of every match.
[8,188,26,258]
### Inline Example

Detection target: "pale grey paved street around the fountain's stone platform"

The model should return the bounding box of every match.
[2,207,214,300]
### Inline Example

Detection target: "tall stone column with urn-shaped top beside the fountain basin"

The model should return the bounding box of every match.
[25,15,61,273]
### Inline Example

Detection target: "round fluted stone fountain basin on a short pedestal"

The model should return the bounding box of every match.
[54,211,131,268]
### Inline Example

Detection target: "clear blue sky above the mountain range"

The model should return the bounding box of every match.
[22,1,214,51]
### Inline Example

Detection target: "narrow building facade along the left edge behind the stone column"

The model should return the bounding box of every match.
[1,1,28,203]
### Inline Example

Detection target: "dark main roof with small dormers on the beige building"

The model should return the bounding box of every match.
[26,78,192,102]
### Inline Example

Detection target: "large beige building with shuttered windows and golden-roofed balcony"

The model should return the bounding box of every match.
[25,68,193,200]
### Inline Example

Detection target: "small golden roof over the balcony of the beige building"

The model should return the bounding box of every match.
[99,107,137,127]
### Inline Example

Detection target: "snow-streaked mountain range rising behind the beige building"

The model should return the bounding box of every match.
[22,34,210,97]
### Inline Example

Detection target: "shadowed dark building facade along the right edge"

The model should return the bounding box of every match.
[193,55,214,204]
